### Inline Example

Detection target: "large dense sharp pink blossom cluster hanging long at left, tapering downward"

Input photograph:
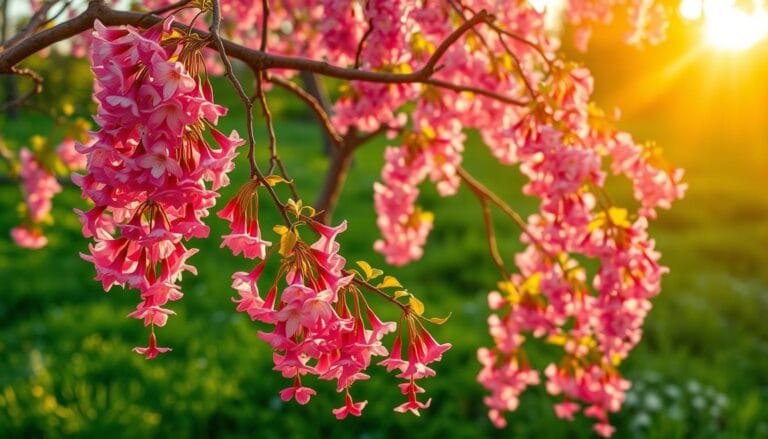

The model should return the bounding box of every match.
[73,18,243,359]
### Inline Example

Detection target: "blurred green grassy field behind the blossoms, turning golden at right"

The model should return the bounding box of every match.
[0,42,768,438]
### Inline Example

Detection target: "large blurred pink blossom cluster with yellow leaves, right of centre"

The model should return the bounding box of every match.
[478,120,685,436]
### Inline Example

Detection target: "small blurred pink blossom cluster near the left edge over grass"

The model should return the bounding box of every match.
[11,148,61,249]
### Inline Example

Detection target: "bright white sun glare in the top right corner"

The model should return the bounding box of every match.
[679,0,768,51]
